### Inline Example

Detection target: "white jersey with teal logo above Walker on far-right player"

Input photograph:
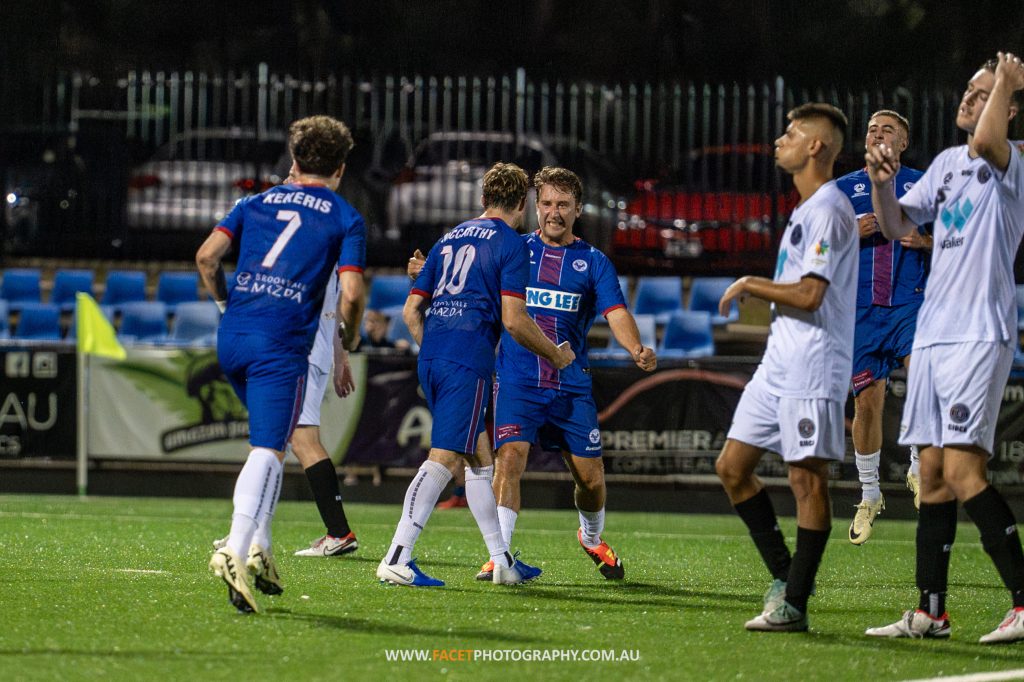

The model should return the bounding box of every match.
[899,142,1024,348]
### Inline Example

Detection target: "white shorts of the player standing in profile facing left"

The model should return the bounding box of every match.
[728,374,846,462]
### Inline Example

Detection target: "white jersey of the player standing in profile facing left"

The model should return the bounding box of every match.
[758,181,858,400]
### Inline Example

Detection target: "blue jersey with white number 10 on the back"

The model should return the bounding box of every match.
[412,218,529,379]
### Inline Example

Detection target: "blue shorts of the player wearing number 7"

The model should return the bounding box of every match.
[217,331,309,451]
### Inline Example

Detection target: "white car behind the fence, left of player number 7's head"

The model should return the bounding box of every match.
[125,128,291,230]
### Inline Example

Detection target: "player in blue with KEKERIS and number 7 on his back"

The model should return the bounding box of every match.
[196,116,366,612]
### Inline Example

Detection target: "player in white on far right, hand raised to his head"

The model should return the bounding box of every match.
[865,52,1024,644]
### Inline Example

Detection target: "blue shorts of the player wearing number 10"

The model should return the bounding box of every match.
[418,358,490,455]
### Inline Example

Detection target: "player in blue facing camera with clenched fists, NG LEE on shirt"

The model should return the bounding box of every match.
[477,166,657,580]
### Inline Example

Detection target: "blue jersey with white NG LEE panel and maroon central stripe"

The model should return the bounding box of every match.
[497,232,626,393]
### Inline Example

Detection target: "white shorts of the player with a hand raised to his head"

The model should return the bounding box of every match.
[899,341,1014,455]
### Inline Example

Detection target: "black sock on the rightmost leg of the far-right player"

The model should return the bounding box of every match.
[964,485,1024,606]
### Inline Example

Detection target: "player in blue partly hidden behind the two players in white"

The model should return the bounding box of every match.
[836,110,932,545]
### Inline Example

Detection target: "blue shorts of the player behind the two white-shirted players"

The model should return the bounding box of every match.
[852,302,921,395]
